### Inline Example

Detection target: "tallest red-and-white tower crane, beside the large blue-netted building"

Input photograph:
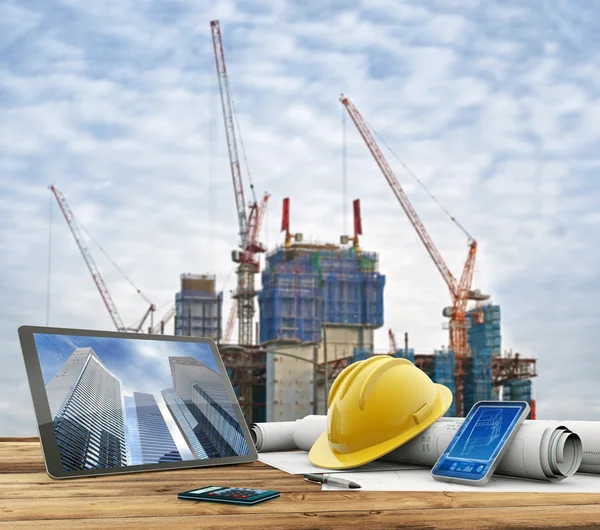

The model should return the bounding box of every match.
[210,20,268,345]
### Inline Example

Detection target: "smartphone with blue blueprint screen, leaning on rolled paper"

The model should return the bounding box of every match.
[431,401,529,486]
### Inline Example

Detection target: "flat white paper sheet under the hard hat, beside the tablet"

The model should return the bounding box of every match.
[258,451,421,475]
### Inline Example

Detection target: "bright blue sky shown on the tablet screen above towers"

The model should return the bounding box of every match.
[34,333,219,460]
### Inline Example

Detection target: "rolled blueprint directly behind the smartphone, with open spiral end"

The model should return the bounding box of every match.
[382,418,583,482]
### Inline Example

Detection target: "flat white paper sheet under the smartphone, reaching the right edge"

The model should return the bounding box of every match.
[321,469,600,493]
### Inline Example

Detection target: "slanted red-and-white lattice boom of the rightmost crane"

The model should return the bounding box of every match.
[340,95,459,298]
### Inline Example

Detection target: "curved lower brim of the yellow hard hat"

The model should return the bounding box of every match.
[308,383,452,469]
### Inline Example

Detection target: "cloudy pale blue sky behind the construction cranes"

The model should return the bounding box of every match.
[0,0,600,435]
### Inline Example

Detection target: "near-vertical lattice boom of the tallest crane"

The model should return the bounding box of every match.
[210,20,248,250]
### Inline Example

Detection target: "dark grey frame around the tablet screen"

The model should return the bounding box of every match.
[18,326,258,479]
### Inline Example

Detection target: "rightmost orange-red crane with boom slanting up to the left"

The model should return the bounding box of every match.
[340,95,489,355]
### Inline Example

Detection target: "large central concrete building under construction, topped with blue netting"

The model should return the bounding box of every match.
[253,233,385,421]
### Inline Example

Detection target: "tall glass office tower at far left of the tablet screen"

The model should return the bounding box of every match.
[46,348,127,471]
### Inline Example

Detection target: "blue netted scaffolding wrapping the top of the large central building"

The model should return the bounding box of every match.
[258,244,385,344]
